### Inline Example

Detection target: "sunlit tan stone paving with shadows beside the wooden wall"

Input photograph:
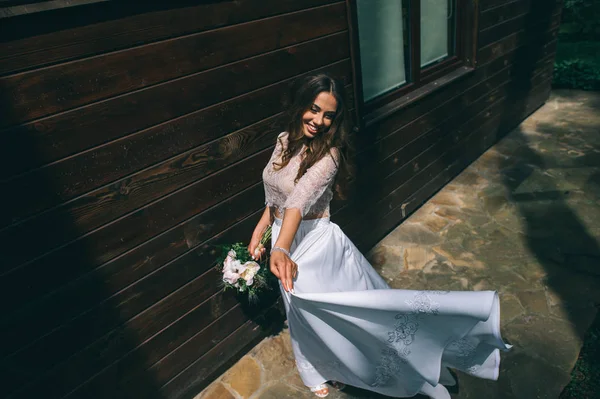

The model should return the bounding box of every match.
[197,91,600,399]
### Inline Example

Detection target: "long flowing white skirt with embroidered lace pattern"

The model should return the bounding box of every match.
[272,218,510,399]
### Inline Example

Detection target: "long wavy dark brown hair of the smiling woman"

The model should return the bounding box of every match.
[274,74,353,199]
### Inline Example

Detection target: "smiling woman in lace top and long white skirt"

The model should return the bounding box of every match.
[248,75,509,399]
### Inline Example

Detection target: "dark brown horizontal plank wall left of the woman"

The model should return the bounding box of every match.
[0,0,352,399]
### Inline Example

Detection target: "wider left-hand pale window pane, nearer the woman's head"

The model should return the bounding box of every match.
[356,0,406,101]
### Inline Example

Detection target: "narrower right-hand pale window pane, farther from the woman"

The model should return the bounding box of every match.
[422,0,453,67]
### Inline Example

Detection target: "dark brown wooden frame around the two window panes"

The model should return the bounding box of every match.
[346,0,478,128]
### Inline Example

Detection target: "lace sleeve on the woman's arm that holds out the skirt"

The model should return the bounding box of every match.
[284,148,339,217]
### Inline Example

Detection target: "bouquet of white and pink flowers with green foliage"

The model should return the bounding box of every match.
[216,226,271,303]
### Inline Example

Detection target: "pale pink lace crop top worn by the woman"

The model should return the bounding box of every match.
[263,132,339,218]
